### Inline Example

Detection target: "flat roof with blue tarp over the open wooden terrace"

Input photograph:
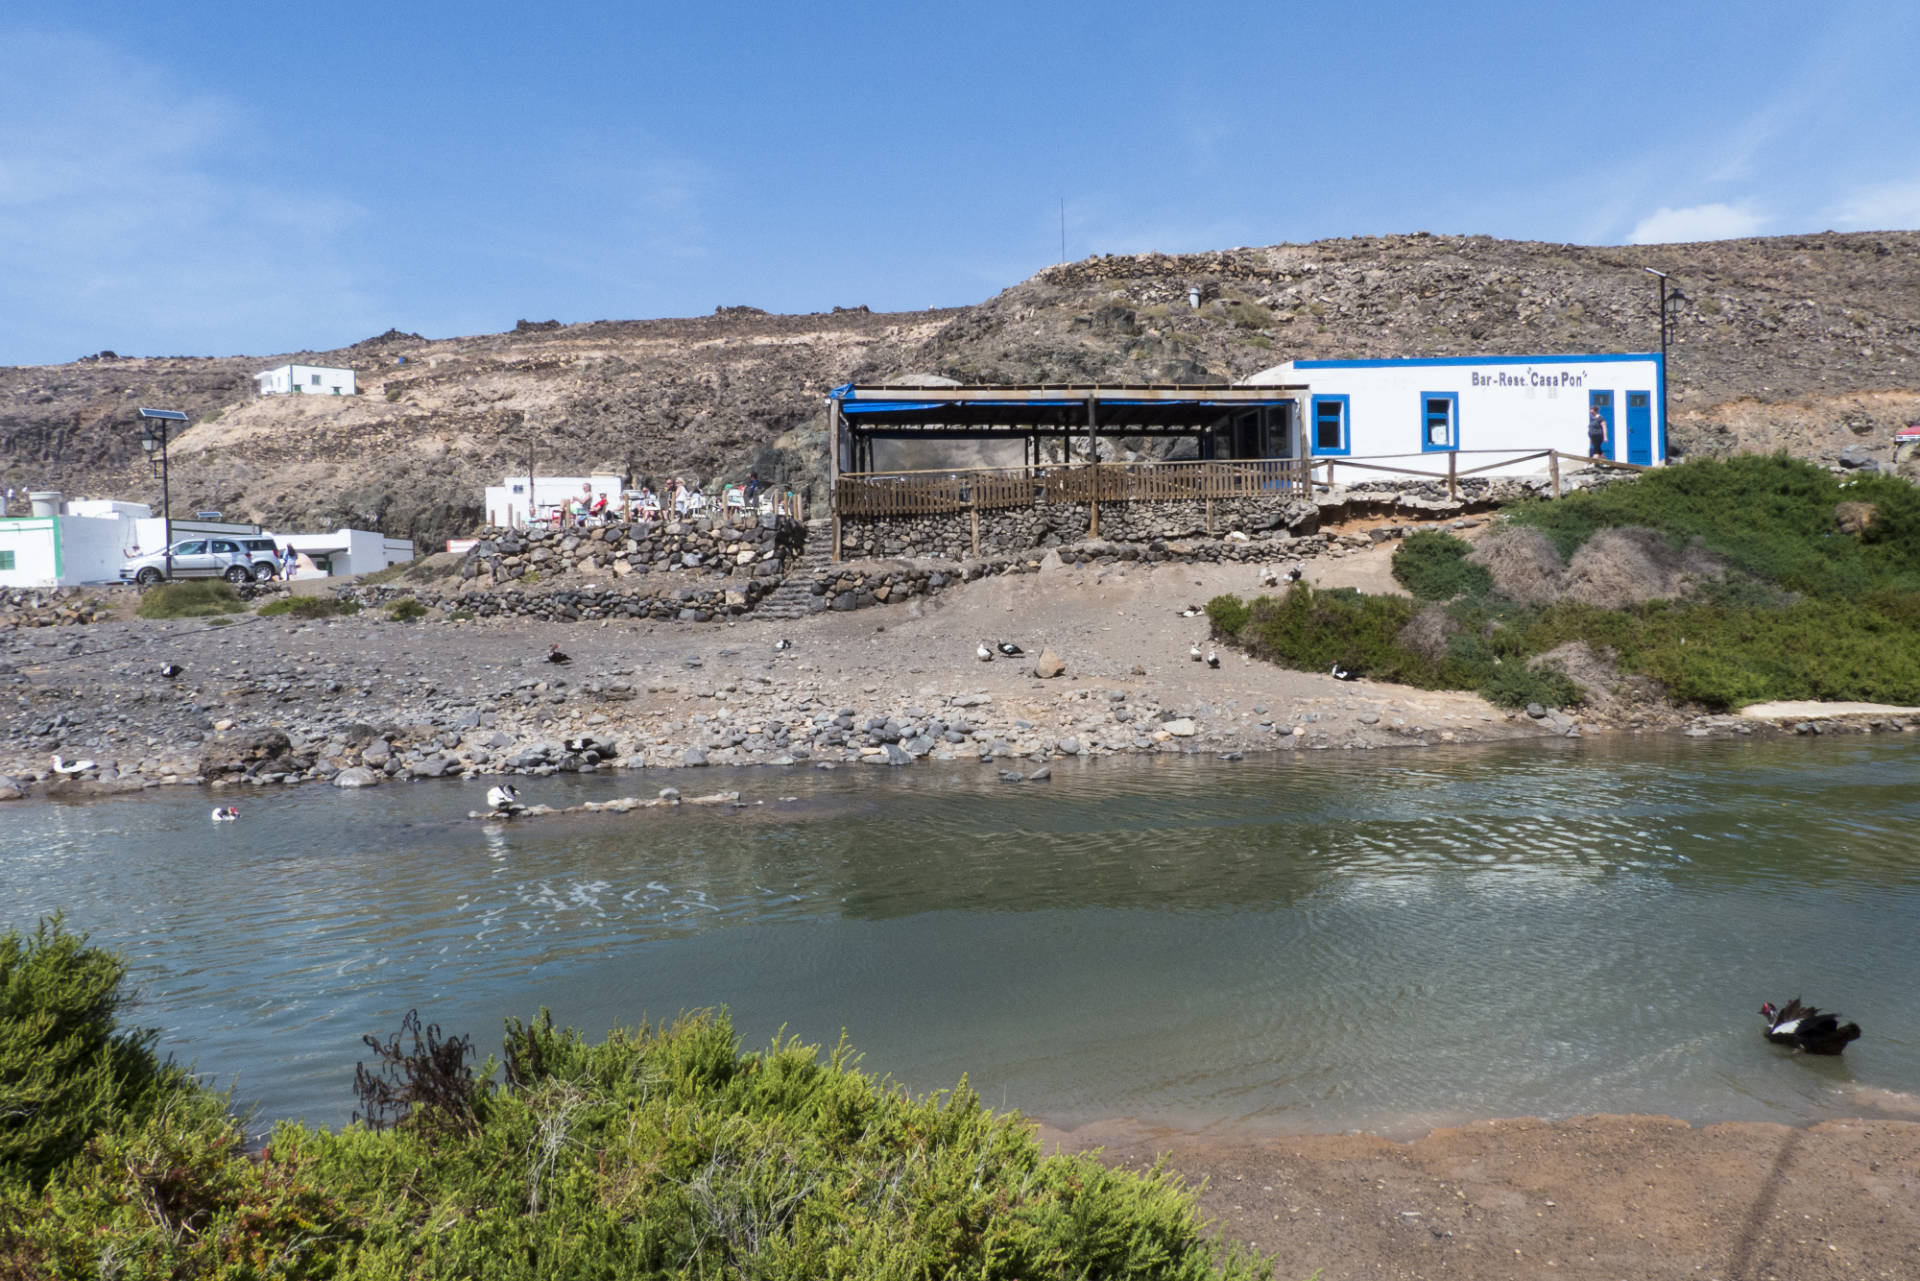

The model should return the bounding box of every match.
[828,382,1306,438]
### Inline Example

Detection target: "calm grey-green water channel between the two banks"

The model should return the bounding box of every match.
[0,739,1920,1131]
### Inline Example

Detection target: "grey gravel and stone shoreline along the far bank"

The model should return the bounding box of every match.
[0,538,1920,797]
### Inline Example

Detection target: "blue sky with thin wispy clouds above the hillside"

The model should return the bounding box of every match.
[0,0,1920,365]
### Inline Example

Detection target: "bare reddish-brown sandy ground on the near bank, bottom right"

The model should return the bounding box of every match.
[1043,1116,1920,1281]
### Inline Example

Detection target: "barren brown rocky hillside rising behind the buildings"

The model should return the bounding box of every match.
[0,232,1920,544]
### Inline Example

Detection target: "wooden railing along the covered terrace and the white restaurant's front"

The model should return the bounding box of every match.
[833,449,1649,517]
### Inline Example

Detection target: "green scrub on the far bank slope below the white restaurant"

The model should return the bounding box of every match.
[1208,455,1920,709]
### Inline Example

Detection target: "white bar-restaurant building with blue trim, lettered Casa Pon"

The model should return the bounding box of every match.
[1246,351,1667,474]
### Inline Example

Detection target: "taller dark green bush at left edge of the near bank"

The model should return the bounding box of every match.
[0,916,173,1187]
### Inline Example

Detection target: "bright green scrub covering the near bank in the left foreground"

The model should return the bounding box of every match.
[0,920,1271,1281]
